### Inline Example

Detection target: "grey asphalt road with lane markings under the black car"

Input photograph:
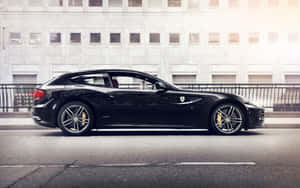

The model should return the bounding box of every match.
[0,129,300,188]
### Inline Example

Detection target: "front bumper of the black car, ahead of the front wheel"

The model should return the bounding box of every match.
[246,105,264,129]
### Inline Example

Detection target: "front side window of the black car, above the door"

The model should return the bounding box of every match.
[112,76,156,90]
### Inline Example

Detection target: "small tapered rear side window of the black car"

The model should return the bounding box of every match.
[71,74,110,87]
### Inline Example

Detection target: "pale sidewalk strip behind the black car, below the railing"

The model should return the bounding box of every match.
[0,113,300,129]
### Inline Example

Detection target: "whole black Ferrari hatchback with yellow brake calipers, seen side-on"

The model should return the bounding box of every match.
[32,69,264,136]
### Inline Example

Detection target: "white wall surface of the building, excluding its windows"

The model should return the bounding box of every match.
[0,0,300,83]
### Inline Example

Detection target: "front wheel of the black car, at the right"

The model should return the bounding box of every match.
[210,103,246,135]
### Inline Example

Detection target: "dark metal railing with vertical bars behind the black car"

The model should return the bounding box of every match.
[0,83,300,112]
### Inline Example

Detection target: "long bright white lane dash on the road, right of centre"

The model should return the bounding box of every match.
[175,162,256,166]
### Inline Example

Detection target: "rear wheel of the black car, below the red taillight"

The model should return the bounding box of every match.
[57,101,94,136]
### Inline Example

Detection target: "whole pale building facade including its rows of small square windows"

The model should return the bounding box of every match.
[0,0,300,83]
